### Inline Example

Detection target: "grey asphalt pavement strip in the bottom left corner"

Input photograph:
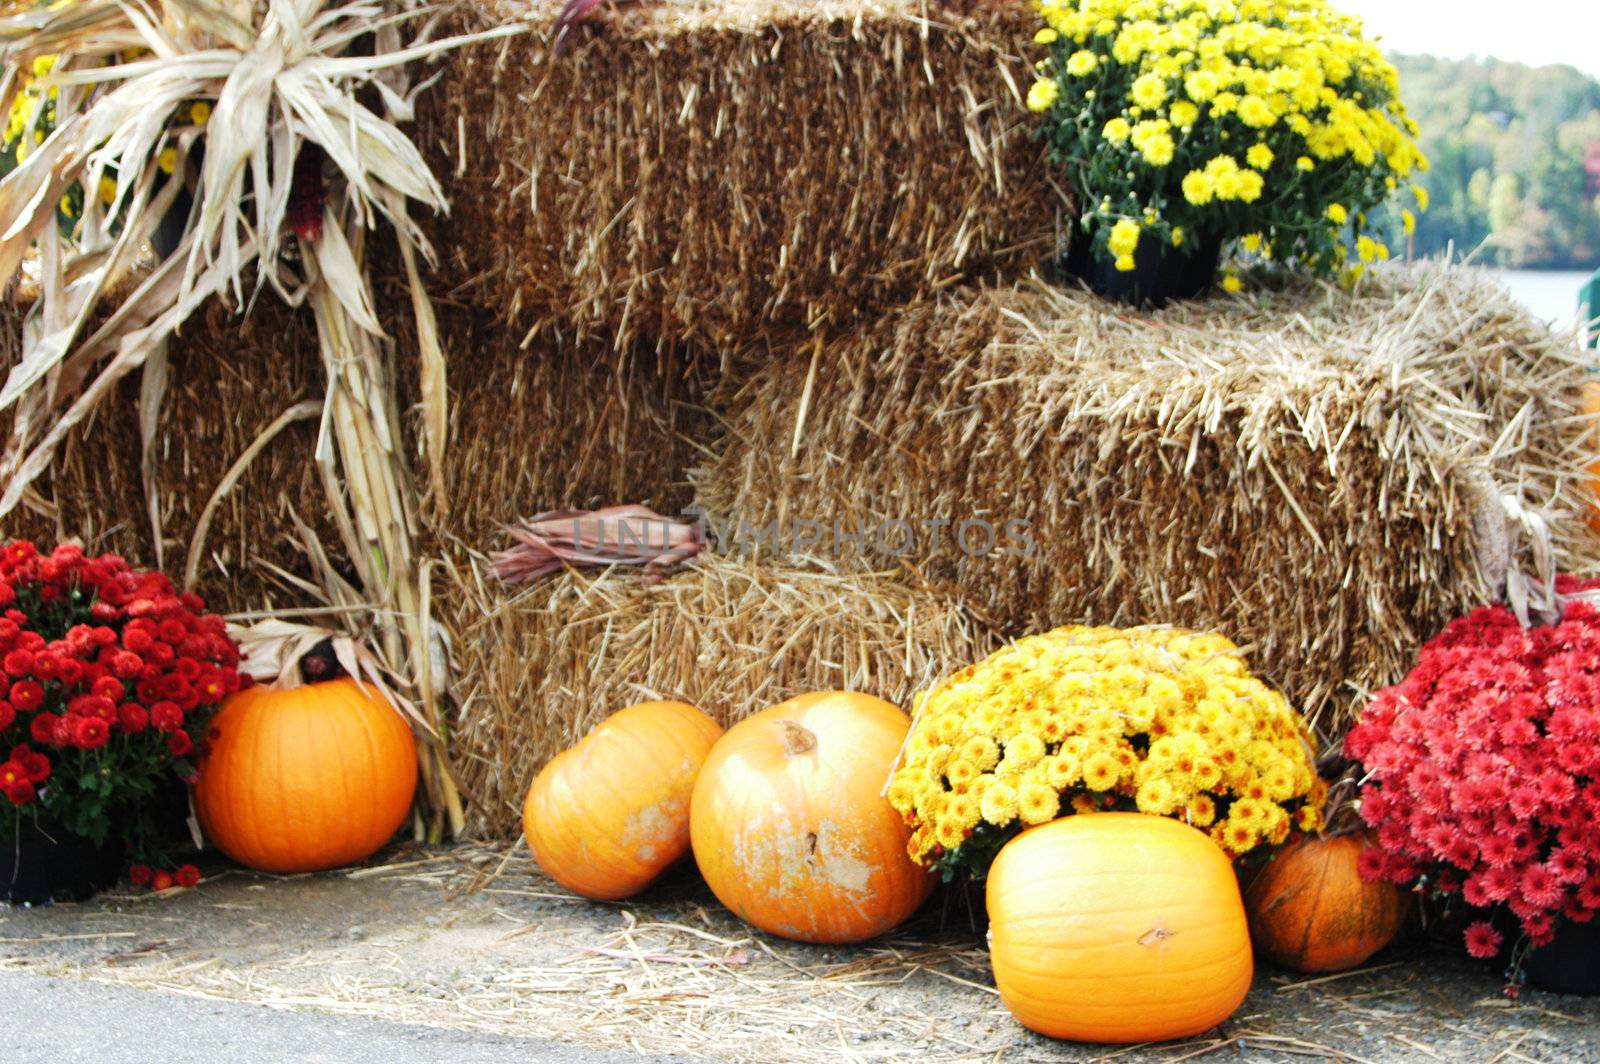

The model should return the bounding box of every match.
[0,971,700,1064]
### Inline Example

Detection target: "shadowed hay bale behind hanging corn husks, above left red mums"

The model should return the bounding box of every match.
[0,293,336,610]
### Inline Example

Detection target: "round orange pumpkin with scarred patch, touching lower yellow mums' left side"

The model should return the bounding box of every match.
[690,691,933,942]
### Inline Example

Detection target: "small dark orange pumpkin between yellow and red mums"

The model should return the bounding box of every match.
[1245,835,1410,971]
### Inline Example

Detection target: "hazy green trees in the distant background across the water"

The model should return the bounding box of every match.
[1392,56,1600,269]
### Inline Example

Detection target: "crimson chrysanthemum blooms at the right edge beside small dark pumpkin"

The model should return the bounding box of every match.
[1344,576,1600,955]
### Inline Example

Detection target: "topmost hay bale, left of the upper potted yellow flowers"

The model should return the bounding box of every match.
[416,0,1062,349]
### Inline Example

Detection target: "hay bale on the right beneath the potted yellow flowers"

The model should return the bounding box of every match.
[696,269,1597,733]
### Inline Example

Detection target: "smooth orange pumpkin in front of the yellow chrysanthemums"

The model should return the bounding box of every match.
[987,813,1254,1042]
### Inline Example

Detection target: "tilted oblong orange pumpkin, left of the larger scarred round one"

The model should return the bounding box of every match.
[522,702,722,901]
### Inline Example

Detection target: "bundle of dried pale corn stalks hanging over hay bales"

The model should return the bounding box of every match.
[0,0,518,837]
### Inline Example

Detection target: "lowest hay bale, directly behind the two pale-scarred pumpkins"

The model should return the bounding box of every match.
[440,555,994,838]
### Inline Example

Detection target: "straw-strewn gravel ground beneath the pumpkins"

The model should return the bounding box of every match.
[0,848,1600,1064]
